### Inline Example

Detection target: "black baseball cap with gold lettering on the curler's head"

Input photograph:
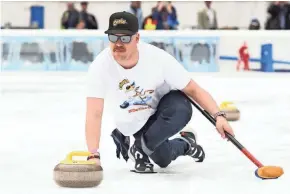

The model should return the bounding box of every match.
[105,11,139,35]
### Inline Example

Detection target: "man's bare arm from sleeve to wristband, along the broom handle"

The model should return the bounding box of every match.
[182,80,220,115]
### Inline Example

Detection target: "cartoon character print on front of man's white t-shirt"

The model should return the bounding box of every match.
[119,79,154,113]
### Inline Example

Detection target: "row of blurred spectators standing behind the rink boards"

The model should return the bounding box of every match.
[2,1,290,30]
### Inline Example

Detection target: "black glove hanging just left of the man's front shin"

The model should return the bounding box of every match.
[111,129,130,162]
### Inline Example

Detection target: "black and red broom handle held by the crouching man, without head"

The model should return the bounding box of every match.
[182,92,263,168]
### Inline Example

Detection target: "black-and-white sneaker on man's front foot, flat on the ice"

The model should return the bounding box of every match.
[129,144,155,173]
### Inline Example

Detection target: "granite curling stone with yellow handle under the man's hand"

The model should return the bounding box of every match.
[53,151,103,188]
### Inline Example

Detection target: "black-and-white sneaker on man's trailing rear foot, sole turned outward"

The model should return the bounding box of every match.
[180,132,205,162]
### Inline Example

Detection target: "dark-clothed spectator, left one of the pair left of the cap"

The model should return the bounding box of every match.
[61,2,79,29]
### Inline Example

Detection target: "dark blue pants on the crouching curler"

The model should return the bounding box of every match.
[134,91,192,168]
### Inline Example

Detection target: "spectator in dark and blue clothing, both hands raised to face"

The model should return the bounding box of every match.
[152,1,179,30]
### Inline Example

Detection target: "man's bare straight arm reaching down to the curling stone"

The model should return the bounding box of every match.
[86,97,104,152]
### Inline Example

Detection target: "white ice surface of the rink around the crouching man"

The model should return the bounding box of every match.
[0,72,290,194]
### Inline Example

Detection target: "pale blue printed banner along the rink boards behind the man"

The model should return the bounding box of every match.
[1,35,219,72]
